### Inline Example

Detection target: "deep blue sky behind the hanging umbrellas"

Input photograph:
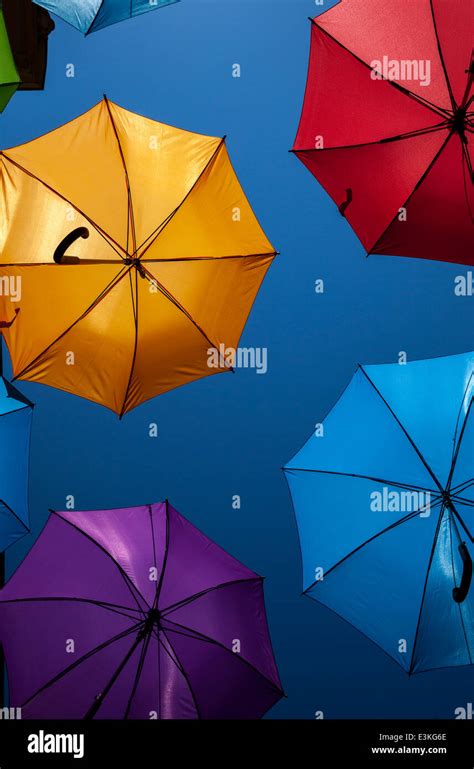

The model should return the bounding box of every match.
[0,0,474,719]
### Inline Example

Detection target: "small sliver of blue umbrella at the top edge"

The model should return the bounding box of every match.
[34,0,179,35]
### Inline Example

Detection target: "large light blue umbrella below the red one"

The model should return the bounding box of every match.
[285,353,474,673]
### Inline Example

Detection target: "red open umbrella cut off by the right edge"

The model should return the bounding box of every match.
[293,0,474,265]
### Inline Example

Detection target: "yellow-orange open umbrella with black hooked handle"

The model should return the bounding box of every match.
[0,99,275,415]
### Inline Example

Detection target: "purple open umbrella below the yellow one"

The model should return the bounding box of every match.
[0,502,282,719]
